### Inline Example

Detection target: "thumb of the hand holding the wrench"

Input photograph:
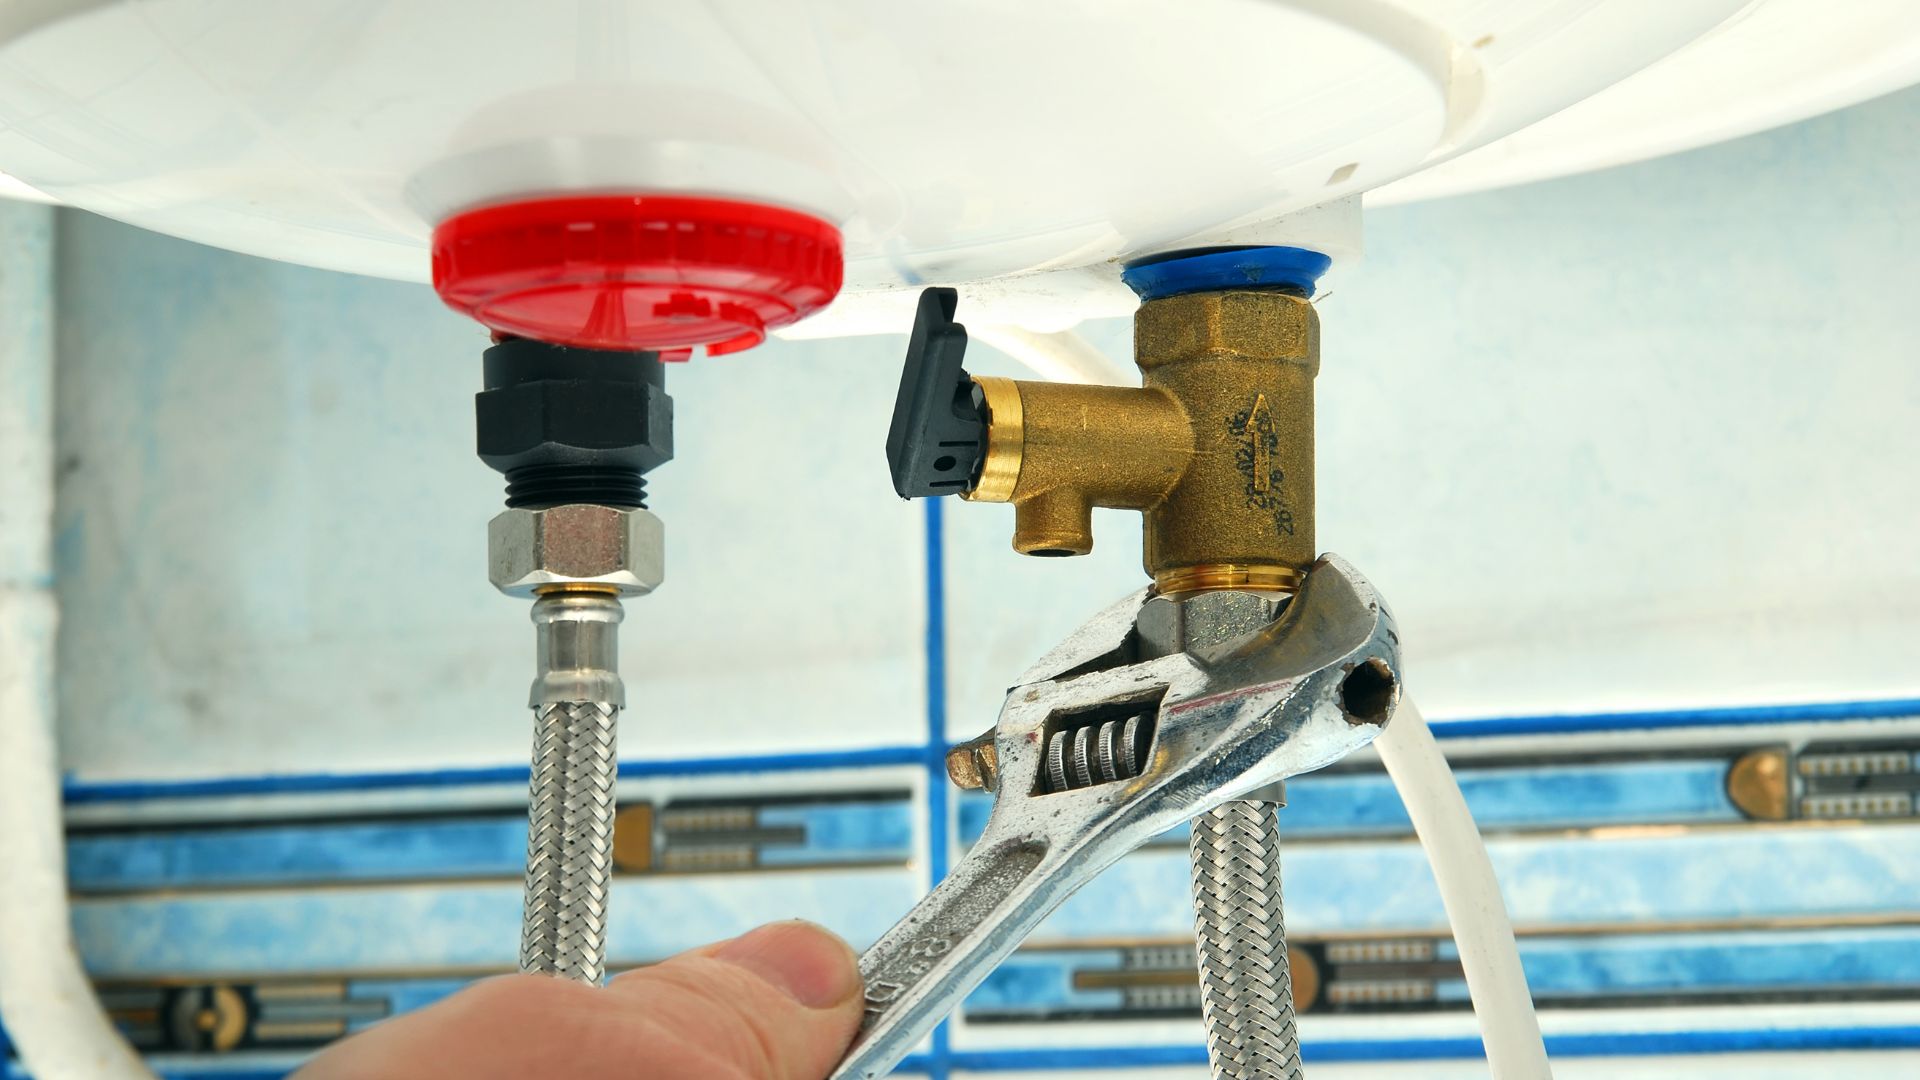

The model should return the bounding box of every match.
[607,920,862,1080]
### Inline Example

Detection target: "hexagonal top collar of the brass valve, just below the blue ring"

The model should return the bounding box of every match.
[1133,288,1319,375]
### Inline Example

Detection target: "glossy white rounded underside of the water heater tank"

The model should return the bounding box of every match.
[0,0,1920,348]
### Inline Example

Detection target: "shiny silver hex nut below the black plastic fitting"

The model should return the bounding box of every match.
[486,503,666,596]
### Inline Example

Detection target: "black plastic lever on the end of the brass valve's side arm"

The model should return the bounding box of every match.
[887,288,987,500]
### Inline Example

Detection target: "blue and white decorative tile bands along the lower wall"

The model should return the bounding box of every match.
[33,705,1920,1076]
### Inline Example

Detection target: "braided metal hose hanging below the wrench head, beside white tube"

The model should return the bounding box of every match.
[1188,799,1304,1080]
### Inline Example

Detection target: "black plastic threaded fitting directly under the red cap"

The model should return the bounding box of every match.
[474,338,674,509]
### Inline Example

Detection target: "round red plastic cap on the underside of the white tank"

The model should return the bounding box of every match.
[434,194,843,359]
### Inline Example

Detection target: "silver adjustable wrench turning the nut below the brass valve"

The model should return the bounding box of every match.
[833,555,1400,1080]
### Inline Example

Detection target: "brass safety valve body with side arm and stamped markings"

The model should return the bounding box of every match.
[966,290,1319,596]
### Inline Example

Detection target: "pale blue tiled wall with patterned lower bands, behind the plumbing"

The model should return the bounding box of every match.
[3,82,1920,1078]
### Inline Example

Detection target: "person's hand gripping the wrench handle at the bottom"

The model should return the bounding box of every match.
[292,922,862,1080]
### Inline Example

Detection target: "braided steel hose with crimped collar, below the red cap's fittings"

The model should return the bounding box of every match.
[520,592,626,982]
